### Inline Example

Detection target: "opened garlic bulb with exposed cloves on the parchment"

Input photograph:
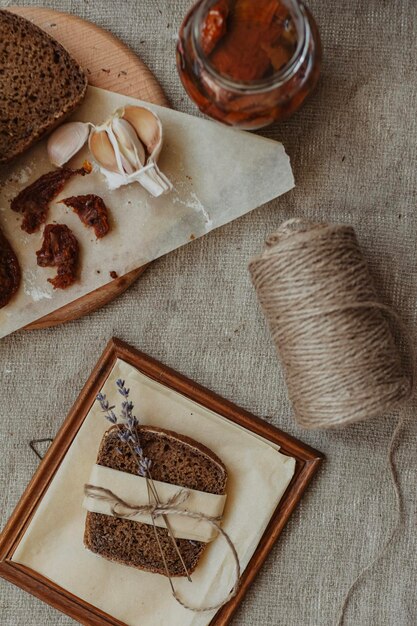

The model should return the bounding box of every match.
[89,106,172,197]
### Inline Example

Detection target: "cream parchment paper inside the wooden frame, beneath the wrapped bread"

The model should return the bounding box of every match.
[13,360,295,626]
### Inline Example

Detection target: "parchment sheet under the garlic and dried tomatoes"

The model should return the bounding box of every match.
[0,87,294,337]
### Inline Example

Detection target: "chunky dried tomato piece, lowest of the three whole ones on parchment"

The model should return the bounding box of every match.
[36,224,79,289]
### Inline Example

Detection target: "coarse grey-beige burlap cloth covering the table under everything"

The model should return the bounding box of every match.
[0,0,417,626]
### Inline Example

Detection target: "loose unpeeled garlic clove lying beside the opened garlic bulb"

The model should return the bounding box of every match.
[46,122,90,167]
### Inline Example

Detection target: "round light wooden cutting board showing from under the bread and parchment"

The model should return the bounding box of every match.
[7,7,169,330]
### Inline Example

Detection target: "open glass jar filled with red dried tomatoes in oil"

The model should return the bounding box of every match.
[177,0,321,129]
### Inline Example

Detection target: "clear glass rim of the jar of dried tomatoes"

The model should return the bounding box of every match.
[191,0,311,94]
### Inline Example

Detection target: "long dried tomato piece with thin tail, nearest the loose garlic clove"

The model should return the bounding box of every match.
[11,162,91,234]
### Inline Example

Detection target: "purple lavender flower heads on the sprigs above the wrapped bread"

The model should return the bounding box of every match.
[97,378,152,478]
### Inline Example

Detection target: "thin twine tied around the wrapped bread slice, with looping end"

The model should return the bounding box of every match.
[84,485,241,613]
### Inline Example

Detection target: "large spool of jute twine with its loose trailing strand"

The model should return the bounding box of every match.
[249,220,415,626]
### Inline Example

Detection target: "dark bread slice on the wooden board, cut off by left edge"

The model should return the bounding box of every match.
[0,10,87,163]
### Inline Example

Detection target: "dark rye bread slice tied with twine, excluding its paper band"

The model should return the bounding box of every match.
[84,426,227,576]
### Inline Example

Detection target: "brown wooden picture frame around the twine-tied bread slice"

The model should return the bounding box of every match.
[0,338,324,626]
